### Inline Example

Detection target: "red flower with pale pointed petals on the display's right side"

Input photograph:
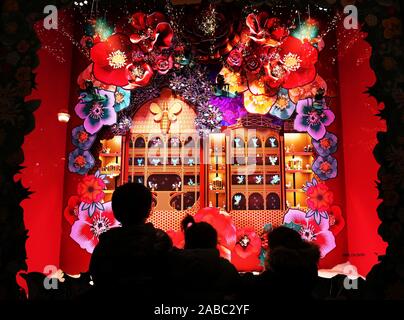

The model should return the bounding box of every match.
[303,178,334,224]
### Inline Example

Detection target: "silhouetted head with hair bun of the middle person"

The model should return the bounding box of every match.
[181,215,217,249]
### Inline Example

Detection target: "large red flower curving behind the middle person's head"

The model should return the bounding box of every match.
[194,207,236,257]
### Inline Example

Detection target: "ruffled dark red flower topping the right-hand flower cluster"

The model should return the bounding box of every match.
[246,12,289,47]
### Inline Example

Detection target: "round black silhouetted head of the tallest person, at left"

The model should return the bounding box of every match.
[112,183,152,226]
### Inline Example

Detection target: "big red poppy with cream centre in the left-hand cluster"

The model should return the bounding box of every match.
[91,33,132,86]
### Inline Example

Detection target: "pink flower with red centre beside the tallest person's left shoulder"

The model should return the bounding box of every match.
[70,202,120,253]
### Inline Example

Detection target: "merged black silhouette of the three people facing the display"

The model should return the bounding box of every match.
[23,183,368,302]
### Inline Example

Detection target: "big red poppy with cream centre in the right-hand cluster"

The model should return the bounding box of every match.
[265,36,318,89]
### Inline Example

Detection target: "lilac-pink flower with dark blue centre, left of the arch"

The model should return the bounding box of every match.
[74,89,117,134]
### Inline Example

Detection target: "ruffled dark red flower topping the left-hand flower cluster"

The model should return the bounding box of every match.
[130,12,174,52]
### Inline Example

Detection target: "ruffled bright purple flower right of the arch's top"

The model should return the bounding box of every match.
[209,96,247,126]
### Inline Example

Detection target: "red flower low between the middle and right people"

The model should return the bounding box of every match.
[231,228,261,271]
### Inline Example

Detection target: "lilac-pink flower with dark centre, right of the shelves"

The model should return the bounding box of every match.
[294,98,335,140]
